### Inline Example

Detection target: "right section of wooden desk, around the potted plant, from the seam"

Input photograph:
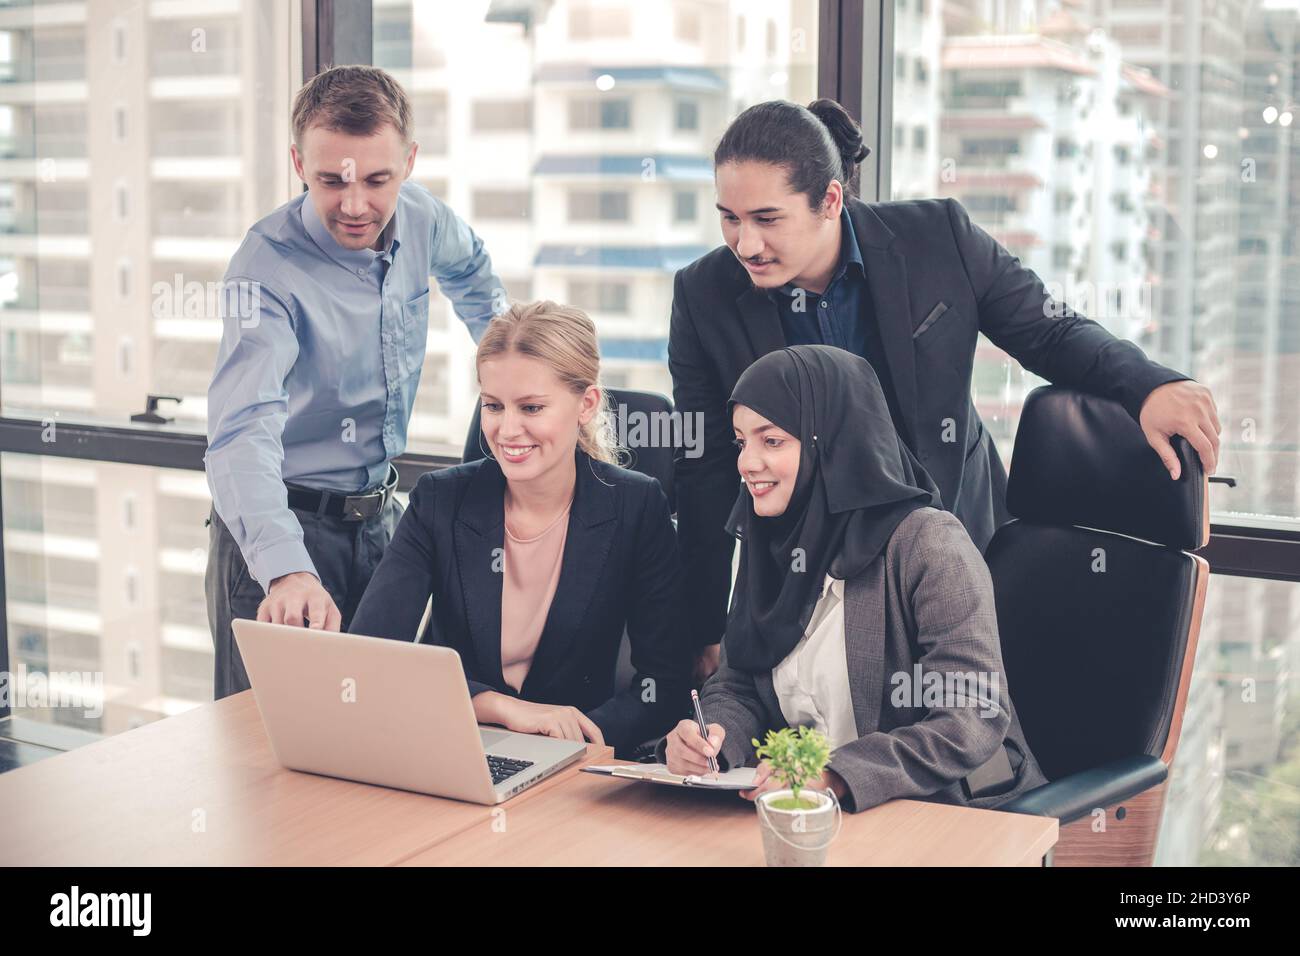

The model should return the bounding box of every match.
[400,773,1057,866]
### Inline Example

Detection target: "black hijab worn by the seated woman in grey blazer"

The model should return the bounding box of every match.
[725,345,943,671]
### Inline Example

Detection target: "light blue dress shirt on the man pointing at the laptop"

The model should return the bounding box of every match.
[204,182,506,591]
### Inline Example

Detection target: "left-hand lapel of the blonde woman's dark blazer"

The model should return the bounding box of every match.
[451,459,506,687]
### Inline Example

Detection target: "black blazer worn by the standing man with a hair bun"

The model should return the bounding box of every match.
[668,199,1187,655]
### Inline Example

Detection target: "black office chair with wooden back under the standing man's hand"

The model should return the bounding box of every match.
[985,386,1209,866]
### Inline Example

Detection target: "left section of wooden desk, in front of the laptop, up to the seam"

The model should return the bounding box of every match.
[0,691,612,866]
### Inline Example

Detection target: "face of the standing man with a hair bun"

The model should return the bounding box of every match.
[715,163,844,293]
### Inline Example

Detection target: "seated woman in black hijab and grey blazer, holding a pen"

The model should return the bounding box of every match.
[660,346,1047,812]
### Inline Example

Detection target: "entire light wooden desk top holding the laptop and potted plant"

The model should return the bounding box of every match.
[0,692,1057,866]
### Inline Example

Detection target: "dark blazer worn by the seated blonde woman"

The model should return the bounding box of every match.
[348,451,693,752]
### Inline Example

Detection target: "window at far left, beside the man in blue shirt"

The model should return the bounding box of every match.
[0,0,299,732]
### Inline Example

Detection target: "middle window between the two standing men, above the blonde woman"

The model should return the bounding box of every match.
[373,0,819,454]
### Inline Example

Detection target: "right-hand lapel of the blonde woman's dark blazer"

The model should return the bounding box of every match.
[520,451,616,698]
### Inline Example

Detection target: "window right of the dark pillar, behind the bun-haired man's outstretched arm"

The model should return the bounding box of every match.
[884,0,1300,865]
